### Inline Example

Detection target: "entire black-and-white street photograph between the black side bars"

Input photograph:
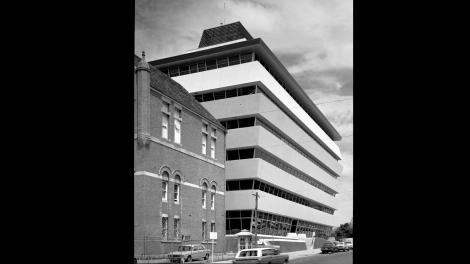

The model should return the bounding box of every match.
[134,0,353,264]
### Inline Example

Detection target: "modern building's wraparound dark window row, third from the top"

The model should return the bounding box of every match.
[220,117,337,178]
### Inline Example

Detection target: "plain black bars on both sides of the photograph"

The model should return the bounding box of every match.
[2,1,468,263]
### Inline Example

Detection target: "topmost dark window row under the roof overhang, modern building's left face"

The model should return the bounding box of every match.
[160,52,254,77]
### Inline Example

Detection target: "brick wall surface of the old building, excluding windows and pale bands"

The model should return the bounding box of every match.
[134,92,225,255]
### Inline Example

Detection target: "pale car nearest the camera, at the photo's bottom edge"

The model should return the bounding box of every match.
[232,247,289,264]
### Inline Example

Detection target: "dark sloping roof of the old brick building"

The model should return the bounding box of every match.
[134,54,226,131]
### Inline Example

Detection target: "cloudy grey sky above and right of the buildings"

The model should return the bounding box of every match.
[135,0,353,226]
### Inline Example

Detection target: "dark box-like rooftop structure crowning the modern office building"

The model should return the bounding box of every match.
[199,22,253,48]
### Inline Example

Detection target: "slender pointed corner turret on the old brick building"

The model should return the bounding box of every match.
[135,51,150,146]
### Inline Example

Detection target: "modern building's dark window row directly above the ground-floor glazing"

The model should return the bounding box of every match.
[226,179,335,214]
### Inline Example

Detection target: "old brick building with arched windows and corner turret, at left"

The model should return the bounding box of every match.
[134,54,226,256]
